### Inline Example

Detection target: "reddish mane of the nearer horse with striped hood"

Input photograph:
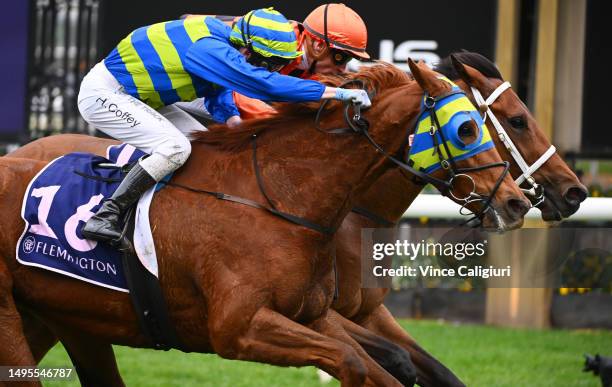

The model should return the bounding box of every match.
[194,62,413,150]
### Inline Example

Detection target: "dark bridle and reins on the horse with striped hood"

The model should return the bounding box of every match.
[315,79,510,221]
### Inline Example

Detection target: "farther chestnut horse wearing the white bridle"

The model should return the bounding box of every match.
[11,52,586,386]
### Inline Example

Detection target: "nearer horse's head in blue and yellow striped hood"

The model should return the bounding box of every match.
[408,60,530,231]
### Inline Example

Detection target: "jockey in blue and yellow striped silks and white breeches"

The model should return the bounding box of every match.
[78,8,370,246]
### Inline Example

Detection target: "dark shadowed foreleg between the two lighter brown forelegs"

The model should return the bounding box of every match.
[337,315,417,386]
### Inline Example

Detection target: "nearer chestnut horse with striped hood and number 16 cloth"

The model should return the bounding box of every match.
[0,62,527,386]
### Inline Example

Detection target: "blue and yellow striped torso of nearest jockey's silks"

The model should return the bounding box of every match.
[104,16,229,109]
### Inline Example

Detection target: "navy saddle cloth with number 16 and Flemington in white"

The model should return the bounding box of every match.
[16,144,163,292]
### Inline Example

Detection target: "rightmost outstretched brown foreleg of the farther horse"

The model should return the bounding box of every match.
[360,305,465,387]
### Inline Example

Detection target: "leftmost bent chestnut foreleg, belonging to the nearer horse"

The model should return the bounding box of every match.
[209,307,397,387]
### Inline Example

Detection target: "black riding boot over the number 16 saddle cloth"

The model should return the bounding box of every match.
[82,163,156,242]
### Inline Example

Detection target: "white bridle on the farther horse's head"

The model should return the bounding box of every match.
[471,81,556,207]
